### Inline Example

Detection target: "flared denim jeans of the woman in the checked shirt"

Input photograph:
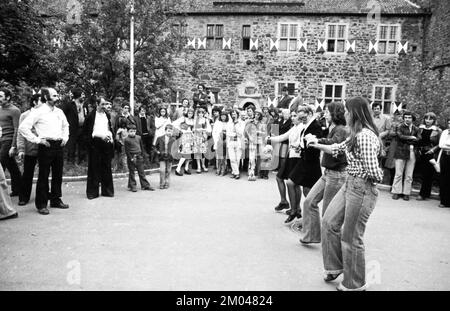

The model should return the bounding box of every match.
[322,176,378,289]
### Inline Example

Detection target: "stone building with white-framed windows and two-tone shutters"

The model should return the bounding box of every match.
[174,0,434,114]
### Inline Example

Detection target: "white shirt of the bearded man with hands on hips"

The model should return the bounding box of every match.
[19,104,69,144]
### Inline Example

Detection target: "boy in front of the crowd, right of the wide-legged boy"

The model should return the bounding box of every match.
[155,124,177,189]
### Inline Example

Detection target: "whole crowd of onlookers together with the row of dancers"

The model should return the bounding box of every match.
[0,84,450,290]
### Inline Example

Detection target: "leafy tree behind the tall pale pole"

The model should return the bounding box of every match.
[56,0,188,108]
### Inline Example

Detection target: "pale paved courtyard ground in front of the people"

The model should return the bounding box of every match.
[0,172,450,291]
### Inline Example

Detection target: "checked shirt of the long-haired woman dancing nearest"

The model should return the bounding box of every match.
[331,128,383,183]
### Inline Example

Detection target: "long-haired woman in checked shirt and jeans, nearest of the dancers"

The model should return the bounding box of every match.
[308,97,383,291]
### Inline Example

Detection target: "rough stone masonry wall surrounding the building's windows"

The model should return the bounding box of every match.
[171,15,424,111]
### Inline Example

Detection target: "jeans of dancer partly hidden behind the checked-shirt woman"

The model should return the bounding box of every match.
[302,169,347,243]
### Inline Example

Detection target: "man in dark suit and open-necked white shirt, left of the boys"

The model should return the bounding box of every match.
[83,98,114,200]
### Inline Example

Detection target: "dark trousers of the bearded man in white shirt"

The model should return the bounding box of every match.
[35,140,64,209]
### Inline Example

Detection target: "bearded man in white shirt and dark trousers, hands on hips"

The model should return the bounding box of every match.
[19,88,69,215]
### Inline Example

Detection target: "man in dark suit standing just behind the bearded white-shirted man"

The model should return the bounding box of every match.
[61,88,86,163]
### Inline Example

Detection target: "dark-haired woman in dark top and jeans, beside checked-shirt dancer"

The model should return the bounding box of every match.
[300,102,348,244]
